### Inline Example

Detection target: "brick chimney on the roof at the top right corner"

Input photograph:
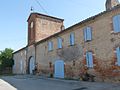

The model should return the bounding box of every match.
[106,0,119,10]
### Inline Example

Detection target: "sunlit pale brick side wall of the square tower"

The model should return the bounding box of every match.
[35,13,63,42]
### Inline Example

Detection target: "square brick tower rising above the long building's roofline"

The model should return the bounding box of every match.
[27,13,64,46]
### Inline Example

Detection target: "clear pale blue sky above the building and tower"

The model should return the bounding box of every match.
[0,0,109,50]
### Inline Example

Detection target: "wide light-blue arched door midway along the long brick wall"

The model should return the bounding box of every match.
[54,60,64,78]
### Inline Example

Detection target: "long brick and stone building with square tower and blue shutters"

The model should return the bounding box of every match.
[13,0,120,81]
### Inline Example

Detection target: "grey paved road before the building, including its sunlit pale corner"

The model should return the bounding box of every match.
[0,76,120,90]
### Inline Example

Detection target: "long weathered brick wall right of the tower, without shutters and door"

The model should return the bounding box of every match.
[36,6,120,81]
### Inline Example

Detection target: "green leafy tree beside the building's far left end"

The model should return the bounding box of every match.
[0,48,14,70]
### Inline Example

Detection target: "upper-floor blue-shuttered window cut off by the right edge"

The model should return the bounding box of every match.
[113,15,120,33]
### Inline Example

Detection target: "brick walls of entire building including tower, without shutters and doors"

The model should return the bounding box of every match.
[13,1,120,82]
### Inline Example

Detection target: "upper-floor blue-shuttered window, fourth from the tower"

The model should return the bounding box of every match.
[84,27,92,41]
